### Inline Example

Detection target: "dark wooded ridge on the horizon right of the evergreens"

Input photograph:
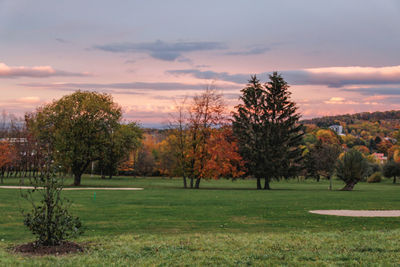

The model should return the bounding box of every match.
[301,110,400,127]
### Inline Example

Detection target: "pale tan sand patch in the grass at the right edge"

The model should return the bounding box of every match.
[310,210,400,217]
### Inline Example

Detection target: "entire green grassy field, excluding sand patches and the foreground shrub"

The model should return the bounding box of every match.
[0,177,400,266]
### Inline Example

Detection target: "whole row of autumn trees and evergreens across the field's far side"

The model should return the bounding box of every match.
[0,72,396,190]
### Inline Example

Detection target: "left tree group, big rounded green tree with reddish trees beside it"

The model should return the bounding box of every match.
[0,91,142,185]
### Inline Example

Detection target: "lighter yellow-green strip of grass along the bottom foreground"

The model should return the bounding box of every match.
[0,230,400,266]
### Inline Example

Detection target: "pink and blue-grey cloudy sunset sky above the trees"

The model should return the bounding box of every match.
[0,0,400,126]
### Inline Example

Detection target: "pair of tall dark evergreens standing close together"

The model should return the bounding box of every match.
[233,72,304,189]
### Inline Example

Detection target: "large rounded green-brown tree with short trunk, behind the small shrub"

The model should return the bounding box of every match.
[27,91,122,185]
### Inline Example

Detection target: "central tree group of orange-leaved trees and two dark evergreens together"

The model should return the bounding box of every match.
[145,73,304,189]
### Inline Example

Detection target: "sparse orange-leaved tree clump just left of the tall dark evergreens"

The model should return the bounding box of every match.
[168,88,243,188]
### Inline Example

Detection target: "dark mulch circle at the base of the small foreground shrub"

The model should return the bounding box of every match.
[14,241,83,256]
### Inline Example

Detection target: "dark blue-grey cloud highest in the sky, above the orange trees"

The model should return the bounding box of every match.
[93,40,226,61]
